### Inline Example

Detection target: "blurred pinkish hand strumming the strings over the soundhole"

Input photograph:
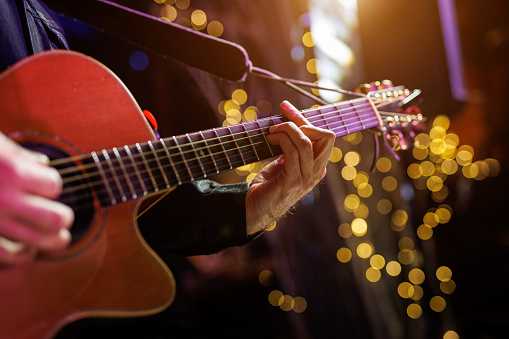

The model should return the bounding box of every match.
[0,133,74,265]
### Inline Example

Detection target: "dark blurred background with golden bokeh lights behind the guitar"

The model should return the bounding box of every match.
[55,0,509,339]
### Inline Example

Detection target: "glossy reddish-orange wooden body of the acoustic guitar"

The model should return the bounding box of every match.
[0,51,175,339]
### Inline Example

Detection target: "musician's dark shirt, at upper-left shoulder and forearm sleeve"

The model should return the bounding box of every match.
[0,0,250,255]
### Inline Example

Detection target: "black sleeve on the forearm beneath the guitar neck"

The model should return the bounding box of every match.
[138,180,252,255]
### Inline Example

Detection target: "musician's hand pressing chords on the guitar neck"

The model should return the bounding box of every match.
[246,101,335,234]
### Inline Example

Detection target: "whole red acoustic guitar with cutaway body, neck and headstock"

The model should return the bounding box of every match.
[0,51,423,339]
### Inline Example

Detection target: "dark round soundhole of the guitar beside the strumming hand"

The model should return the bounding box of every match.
[22,142,95,243]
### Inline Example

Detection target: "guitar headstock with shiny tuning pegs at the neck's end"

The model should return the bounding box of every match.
[357,80,426,149]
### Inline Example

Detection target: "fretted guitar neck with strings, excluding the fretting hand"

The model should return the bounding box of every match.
[63,97,381,206]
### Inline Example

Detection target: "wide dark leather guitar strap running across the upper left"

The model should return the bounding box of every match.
[44,0,251,81]
